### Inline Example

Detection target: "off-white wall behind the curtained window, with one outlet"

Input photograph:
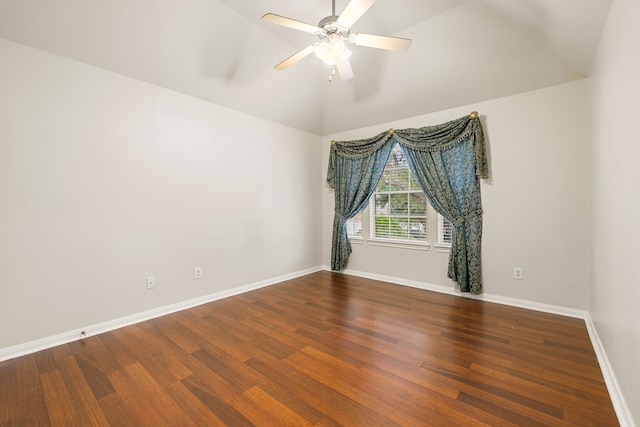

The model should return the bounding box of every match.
[323,80,589,310]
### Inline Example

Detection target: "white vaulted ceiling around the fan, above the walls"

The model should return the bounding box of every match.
[0,0,611,135]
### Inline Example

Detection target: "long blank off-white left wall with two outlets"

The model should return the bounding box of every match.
[0,39,321,349]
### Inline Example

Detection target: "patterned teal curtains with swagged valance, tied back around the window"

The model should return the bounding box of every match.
[327,112,488,294]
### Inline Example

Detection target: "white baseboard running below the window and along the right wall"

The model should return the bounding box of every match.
[324,265,636,427]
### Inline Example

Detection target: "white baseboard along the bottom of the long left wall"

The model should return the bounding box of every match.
[0,266,323,362]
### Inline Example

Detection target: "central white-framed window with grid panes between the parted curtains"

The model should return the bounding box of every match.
[369,144,427,243]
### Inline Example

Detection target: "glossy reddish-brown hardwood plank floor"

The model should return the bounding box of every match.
[0,272,618,427]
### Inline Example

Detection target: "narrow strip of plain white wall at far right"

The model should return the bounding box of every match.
[589,0,640,425]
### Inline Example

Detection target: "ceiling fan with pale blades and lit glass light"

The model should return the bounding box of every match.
[261,0,411,81]
